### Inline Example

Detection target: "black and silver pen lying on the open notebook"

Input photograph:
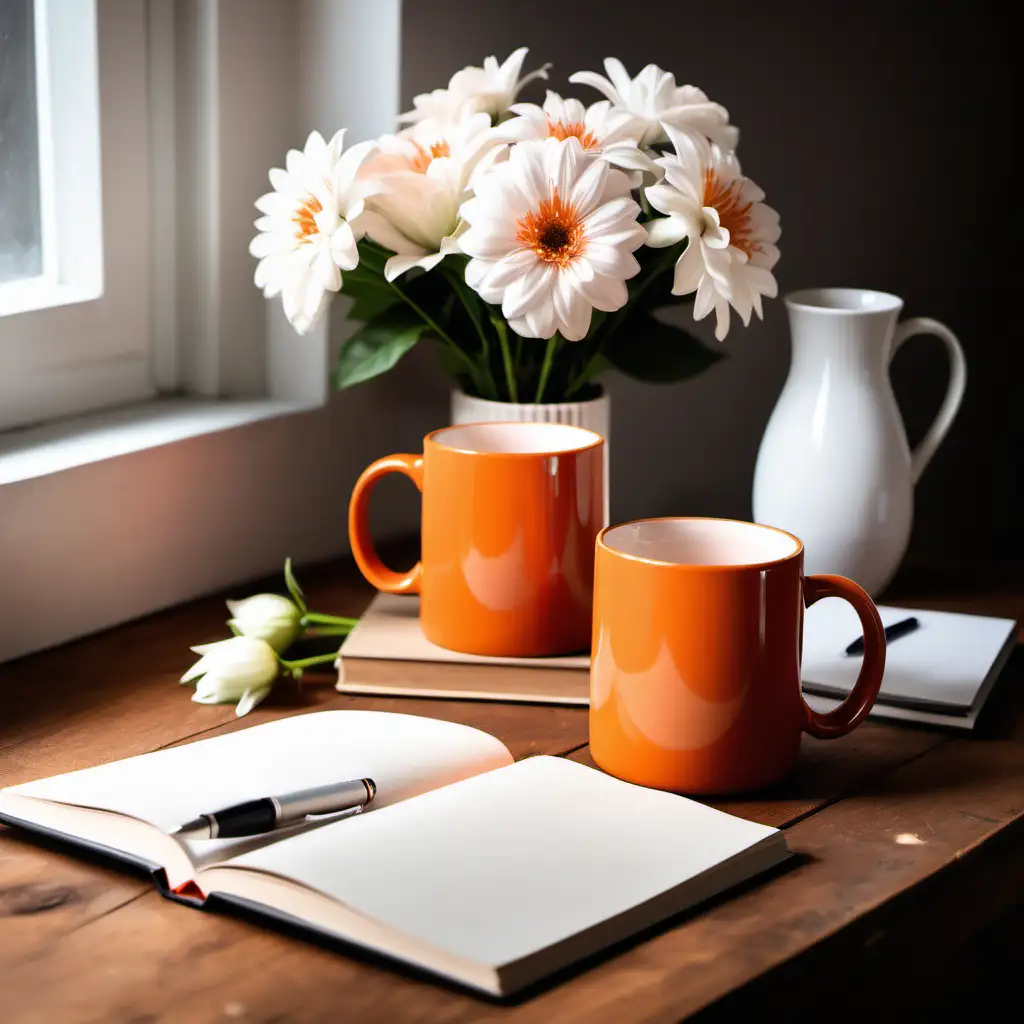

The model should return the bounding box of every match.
[171,778,377,839]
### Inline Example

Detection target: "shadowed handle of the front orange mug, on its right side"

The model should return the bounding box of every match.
[804,575,886,739]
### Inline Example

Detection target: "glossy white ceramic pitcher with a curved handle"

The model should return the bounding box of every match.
[754,288,967,595]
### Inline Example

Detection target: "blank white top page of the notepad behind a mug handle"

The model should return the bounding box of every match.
[802,599,1016,709]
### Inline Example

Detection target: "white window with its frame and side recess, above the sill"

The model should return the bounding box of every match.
[0,0,399,431]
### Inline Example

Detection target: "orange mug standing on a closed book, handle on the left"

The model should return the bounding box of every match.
[348,423,605,657]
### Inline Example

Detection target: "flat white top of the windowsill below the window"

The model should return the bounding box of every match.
[0,398,316,486]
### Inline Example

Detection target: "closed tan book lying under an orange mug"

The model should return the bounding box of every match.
[337,594,590,707]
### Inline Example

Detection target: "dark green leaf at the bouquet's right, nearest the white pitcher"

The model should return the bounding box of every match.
[604,309,725,384]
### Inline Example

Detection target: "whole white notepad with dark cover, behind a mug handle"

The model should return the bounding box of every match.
[803,601,1017,729]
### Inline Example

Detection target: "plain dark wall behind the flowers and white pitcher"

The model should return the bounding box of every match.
[401,0,1024,563]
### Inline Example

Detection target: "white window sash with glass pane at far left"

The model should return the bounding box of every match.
[0,0,153,430]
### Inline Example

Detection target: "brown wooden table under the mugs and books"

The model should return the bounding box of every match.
[0,563,1024,1024]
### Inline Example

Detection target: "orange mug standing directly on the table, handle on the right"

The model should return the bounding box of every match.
[590,518,886,794]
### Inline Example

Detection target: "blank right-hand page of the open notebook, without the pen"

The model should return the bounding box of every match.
[234,757,776,967]
